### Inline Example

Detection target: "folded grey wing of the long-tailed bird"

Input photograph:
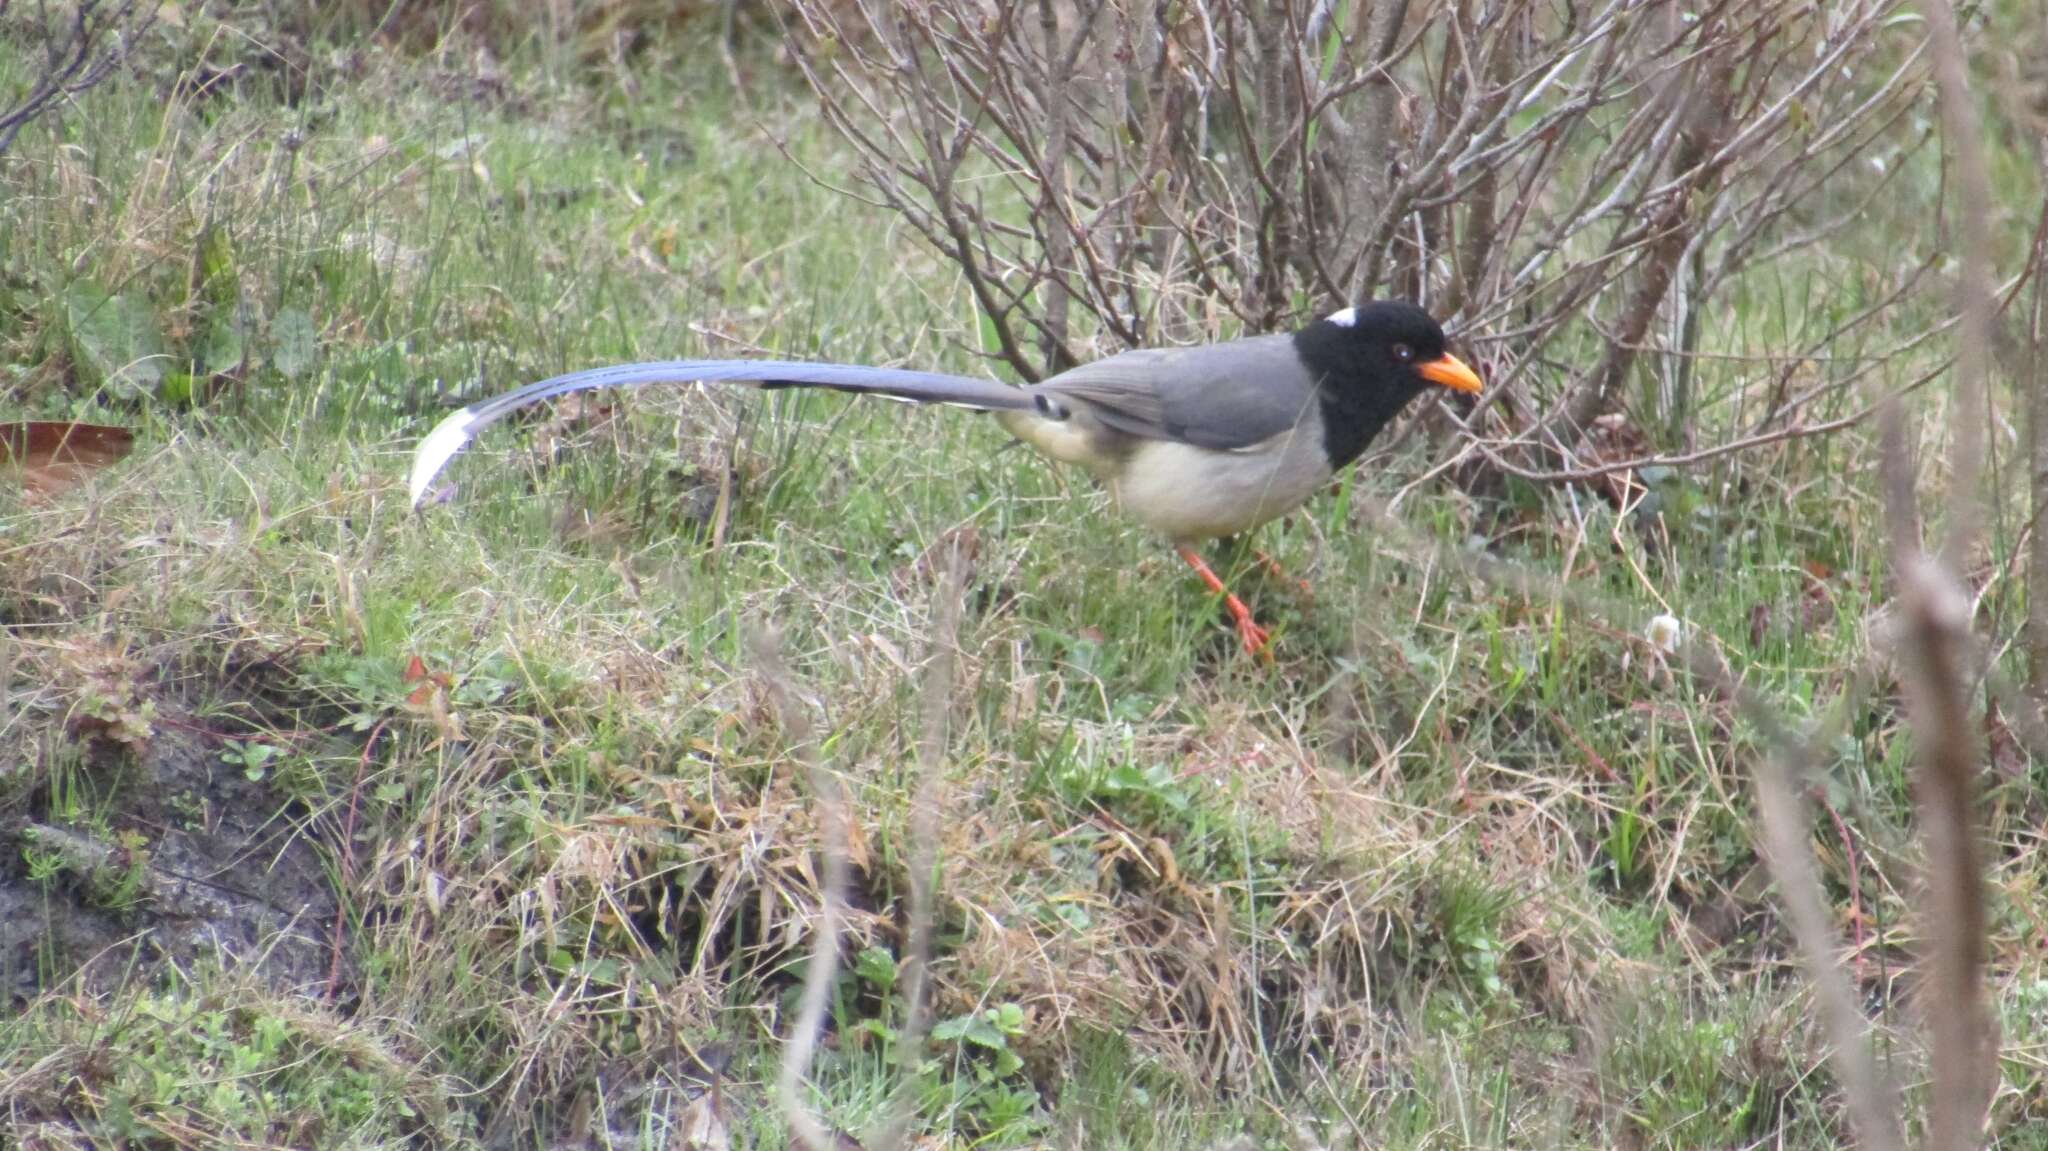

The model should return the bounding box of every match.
[1030,334,1315,451]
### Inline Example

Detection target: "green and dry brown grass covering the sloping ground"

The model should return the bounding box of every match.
[0,11,2048,1147]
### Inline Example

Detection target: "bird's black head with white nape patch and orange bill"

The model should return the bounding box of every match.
[1294,299,1483,467]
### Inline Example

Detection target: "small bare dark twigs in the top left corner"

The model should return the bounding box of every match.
[0,0,160,156]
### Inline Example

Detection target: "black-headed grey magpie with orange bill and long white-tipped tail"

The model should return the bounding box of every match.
[412,301,1481,653]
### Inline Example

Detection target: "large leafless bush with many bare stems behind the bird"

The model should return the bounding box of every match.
[788,0,1949,477]
